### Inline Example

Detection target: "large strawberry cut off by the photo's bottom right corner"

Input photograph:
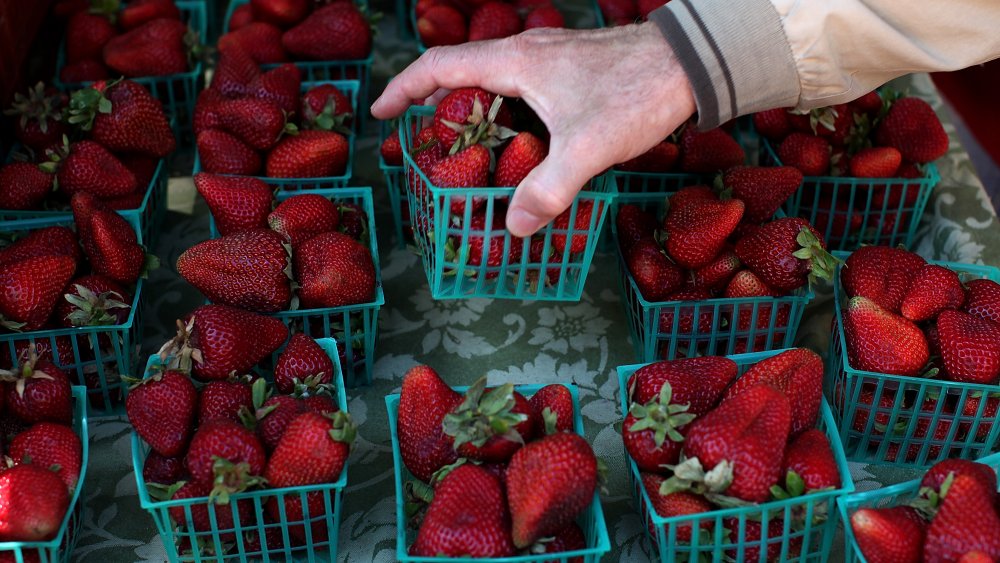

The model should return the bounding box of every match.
[920,474,1000,563]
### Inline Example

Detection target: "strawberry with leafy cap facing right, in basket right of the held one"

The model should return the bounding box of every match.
[736,217,836,292]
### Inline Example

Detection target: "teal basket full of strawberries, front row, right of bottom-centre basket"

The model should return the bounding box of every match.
[618,348,854,562]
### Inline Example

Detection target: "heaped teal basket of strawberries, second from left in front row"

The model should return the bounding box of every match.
[126,338,356,563]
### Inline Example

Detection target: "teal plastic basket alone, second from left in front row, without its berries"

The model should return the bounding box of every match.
[132,338,349,563]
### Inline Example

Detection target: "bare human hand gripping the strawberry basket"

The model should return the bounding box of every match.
[371,23,695,237]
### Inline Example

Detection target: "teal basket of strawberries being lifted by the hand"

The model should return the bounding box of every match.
[399,88,615,301]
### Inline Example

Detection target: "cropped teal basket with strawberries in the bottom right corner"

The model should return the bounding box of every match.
[838,454,1000,563]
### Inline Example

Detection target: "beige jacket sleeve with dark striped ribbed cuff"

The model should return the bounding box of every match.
[650,0,1000,128]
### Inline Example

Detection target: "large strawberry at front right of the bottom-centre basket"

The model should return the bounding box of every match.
[507,432,597,548]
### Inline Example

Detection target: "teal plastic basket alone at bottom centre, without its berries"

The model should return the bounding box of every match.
[385,383,611,563]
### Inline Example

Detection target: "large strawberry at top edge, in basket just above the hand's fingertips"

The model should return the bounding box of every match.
[281,2,372,61]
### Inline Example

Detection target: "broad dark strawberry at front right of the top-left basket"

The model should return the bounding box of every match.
[103,18,188,77]
